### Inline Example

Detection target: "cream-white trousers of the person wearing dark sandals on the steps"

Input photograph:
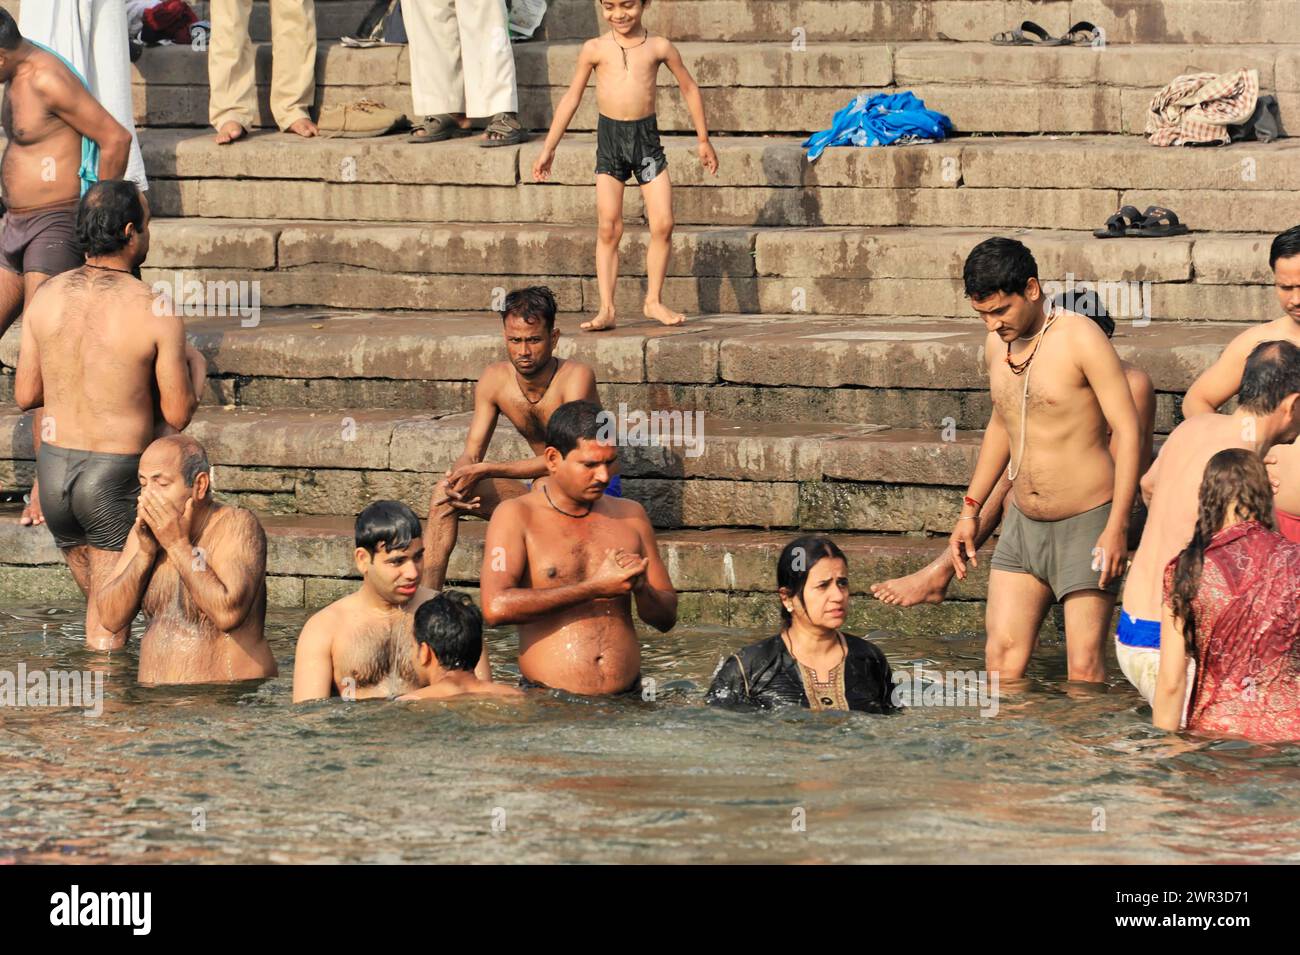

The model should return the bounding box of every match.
[402,0,519,117]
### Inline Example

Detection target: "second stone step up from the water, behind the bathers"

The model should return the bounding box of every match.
[0,407,980,531]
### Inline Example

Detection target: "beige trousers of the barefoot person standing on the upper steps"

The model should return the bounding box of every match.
[208,0,316,130]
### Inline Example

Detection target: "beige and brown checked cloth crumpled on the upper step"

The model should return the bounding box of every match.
[1147,70,1260,146]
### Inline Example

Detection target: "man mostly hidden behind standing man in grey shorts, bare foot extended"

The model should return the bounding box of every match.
[871,294,1156,607]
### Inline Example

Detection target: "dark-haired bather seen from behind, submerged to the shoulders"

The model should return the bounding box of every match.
[398,590,524,700]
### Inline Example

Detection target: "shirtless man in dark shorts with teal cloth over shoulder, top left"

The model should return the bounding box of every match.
[0,10,131,524]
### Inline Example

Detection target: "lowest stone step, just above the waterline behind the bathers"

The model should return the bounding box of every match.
[0,505,988,634]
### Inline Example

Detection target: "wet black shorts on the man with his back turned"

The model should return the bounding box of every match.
[36,443,140,551]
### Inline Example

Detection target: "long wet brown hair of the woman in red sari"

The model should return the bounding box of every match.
[1170,448,1274,657]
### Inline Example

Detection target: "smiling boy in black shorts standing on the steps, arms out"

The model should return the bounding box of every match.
[533,0,718,331]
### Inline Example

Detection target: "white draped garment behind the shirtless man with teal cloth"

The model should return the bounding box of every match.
[18,0,150,190]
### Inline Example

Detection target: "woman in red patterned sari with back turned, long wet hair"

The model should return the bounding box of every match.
[1152,448,1300,742]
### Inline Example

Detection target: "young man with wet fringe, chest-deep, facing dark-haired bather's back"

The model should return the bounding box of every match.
[294,500,491,703]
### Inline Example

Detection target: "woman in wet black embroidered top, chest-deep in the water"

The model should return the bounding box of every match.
[706,535,896,713]
